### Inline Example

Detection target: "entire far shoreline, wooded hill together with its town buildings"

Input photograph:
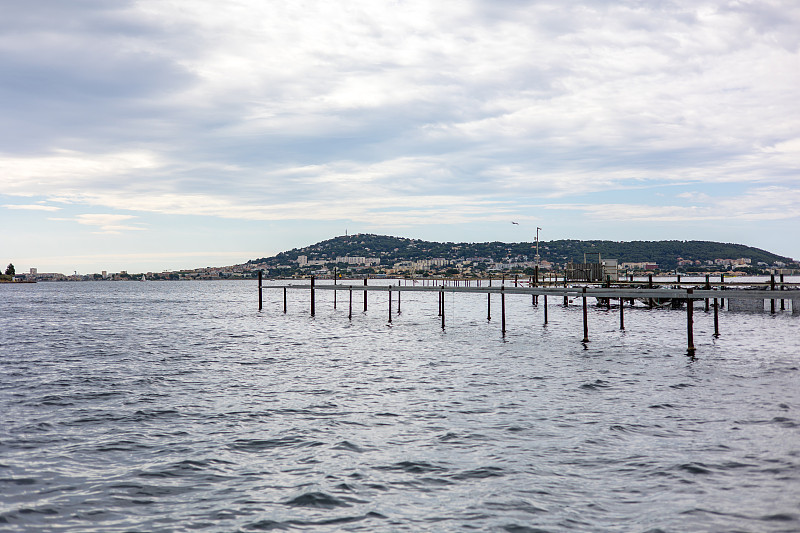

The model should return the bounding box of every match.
[0,234,800,282]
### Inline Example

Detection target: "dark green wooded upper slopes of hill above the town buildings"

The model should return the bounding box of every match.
[248,234,794,270]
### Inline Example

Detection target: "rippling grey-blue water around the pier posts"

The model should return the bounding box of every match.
[0,282,800,532]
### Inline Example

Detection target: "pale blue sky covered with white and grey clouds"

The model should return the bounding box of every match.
[0,0,800,274]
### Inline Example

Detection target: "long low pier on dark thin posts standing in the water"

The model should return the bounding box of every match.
[258,272,800,356]
